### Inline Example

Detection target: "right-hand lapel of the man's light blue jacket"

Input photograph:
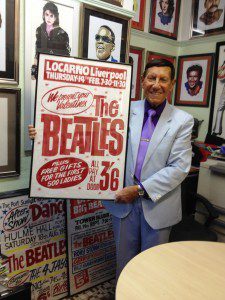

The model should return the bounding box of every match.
[142,103,173,169]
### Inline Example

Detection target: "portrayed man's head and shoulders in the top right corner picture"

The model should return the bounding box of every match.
[199,0,223,25]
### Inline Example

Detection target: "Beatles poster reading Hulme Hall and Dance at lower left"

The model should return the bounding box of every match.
[0,195,67,300]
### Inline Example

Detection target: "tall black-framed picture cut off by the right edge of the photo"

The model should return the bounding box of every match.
[208,42,225,143]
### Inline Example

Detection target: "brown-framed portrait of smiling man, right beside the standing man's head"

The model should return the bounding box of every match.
[175,53,214,107]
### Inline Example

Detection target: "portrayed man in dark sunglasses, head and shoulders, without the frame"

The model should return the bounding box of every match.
[95,25,117,62]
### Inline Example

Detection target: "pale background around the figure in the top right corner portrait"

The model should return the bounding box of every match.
[197,0,225,31]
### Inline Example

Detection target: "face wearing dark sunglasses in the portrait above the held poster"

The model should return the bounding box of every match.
[95,27,115,60]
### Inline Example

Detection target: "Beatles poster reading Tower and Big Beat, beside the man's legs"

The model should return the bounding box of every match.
[67,200,116,295]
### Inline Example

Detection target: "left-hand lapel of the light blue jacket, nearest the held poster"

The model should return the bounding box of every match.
[130,101,145,168]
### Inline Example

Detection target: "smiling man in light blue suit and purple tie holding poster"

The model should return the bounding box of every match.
[104,59,193,278]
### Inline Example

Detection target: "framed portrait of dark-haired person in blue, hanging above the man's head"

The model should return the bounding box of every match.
[149,0,181,40]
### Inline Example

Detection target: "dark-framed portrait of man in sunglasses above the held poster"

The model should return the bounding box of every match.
[80,4,131,62]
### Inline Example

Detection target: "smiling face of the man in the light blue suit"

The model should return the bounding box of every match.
[142,67,175,106]
